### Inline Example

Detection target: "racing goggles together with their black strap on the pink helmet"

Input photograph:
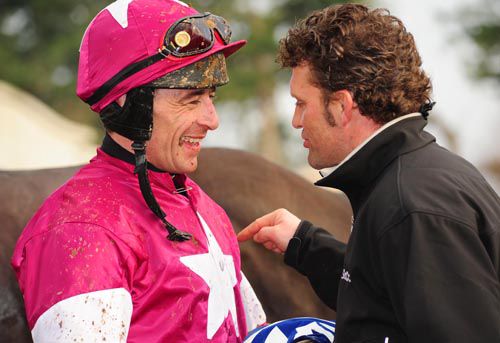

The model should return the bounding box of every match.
[86,12,231,106]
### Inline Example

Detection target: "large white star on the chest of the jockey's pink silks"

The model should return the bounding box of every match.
[180,213,239,339]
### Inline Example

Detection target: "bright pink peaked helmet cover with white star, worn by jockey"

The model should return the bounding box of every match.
[76,0,246,112]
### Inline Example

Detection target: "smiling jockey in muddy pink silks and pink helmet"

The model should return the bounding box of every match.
[12,0,265,342]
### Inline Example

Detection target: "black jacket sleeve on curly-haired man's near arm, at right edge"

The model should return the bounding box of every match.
[378,213,500,342]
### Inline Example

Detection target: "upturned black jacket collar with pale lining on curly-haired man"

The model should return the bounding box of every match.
[315,115,436,213]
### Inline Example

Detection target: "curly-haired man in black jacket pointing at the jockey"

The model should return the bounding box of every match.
[239,4,500,343]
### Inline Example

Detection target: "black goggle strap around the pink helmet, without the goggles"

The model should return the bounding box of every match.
[85,49,171,106]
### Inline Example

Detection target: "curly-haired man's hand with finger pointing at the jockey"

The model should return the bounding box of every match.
[238,208,300,254]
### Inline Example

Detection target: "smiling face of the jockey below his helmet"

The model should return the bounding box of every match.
[146,88,219,174]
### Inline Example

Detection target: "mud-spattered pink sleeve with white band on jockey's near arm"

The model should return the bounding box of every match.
[16,223,141,342]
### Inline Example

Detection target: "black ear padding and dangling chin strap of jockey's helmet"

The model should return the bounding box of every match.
[100,87,191,242]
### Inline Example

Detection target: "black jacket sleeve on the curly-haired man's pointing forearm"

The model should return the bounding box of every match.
[285,220,346,310]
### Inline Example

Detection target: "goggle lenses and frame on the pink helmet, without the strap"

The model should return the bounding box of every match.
[159,12,231,57]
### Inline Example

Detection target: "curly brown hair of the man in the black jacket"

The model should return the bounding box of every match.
[277,4,432,124]
